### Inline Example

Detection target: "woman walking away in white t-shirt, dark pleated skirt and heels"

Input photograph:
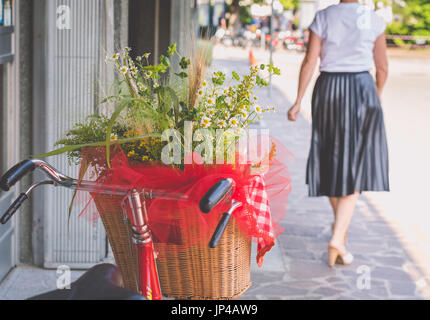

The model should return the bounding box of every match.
[288,0,389,266]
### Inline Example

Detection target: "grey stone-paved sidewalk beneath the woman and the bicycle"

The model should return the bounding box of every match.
[0,47,430,300]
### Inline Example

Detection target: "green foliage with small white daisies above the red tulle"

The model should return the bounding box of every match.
[47,45,280,165]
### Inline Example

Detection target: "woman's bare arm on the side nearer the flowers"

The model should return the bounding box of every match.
[288,31,321,121]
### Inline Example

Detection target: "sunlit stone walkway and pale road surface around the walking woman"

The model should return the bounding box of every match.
[213,46,430,299]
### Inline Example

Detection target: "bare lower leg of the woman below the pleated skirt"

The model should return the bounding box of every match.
[330,191,360,254]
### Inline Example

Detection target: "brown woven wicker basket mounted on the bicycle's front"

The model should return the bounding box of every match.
[94,195,251,300]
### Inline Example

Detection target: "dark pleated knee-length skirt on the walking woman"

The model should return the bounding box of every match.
[306,71,389,197]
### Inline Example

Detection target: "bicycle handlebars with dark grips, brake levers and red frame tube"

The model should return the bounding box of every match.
[0,159,242,300]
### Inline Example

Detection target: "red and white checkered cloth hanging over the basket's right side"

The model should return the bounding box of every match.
[245,175,275,267]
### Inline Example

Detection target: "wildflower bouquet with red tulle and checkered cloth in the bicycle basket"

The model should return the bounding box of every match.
[42,44,290,298]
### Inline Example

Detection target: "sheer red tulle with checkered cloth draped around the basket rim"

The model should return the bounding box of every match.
[74,138,292,267]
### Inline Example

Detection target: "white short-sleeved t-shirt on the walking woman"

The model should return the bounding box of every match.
[309,2,385,72]
